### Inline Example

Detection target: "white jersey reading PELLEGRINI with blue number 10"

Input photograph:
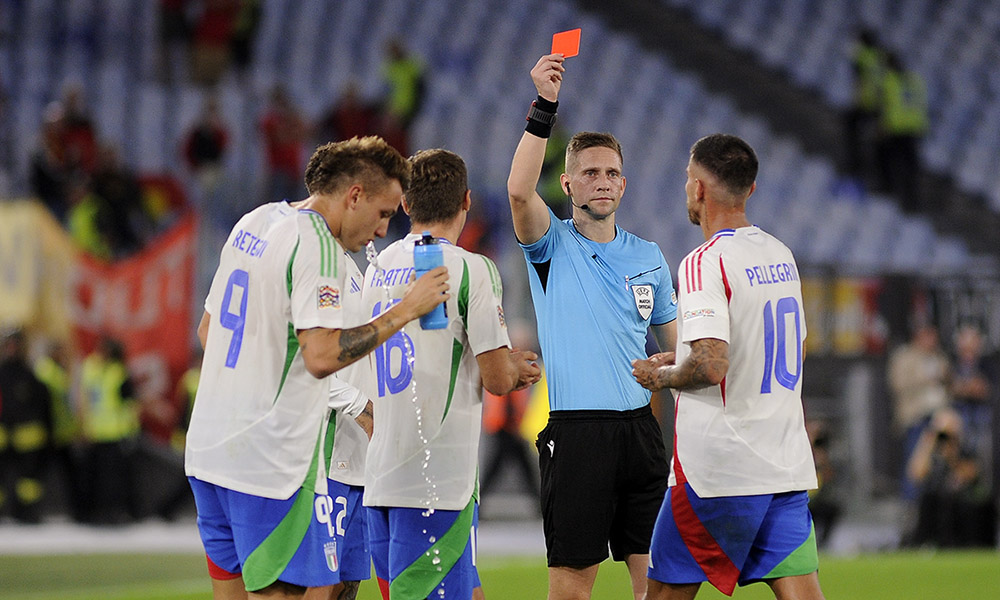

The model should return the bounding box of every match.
[670,227,816,497]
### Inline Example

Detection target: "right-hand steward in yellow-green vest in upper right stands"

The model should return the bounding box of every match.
[879,52,928,213]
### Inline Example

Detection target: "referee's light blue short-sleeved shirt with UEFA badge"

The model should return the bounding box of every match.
[521,210,677,411]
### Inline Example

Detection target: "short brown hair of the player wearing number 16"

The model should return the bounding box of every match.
[405,148,469,223]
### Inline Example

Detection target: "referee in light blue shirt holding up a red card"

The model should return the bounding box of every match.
[507,54,677,600]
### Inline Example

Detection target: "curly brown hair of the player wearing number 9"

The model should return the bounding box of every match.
[305,135,410,194]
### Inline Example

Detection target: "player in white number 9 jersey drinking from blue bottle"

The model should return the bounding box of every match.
[185,137,448,599]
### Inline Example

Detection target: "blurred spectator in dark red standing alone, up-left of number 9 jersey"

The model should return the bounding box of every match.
[184,95,229,220]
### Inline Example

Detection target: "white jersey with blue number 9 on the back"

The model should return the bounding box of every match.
[185,202,356,499]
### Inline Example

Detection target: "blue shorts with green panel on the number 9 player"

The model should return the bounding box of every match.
[188,477,340,592]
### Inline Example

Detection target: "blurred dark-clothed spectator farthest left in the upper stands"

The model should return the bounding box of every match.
[29,102,70,222]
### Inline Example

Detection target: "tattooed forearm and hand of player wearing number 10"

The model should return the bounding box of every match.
[632,338,729,391]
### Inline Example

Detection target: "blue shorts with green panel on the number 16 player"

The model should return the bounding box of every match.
[367,500,480,600]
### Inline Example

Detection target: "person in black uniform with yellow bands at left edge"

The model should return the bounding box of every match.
[0,329,52,523]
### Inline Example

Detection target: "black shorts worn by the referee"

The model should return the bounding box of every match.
[535,405,669,567]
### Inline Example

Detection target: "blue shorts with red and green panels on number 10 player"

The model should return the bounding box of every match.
[648,483,819,595]
